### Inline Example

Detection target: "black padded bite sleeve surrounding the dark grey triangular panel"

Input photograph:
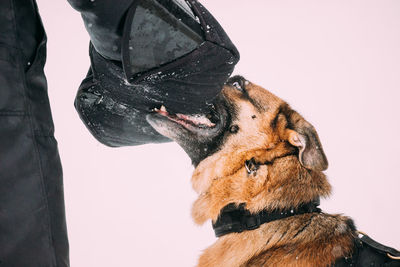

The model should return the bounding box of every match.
[70,0,239,147]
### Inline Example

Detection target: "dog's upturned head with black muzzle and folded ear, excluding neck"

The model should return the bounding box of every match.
[147,76,328,171]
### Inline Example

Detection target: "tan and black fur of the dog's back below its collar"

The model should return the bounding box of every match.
[197,213,354,267]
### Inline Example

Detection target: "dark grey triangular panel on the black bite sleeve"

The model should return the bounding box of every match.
[122,0,205,80]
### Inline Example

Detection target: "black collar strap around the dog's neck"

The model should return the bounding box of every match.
[212,198,321,237]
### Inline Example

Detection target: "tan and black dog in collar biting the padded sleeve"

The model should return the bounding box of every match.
[147,76,400,267]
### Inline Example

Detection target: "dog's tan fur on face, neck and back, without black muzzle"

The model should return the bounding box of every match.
[192,83,354,267]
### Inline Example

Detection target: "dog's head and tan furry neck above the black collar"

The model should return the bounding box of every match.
[147,76,330,224]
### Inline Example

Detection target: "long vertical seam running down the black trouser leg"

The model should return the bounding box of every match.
[10,0,57,267]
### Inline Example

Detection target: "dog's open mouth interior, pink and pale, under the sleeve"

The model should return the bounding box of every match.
[153,105,219,130]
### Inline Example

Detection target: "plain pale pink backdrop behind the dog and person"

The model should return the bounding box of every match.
[38,0,400,267]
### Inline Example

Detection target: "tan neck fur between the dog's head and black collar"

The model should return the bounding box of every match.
[192,155,331,224]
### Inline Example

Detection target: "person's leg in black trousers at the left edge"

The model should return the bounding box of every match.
[0,0,69,267]
